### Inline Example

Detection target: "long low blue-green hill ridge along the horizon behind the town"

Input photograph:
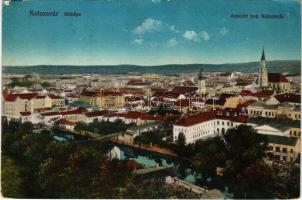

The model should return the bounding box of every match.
[2,60,301,75]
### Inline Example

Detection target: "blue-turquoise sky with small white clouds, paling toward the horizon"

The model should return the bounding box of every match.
[2,0,301,66]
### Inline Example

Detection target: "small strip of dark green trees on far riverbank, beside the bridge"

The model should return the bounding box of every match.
[74,120,135,135]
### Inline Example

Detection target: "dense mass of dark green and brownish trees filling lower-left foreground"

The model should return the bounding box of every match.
[1,121,195,198]
